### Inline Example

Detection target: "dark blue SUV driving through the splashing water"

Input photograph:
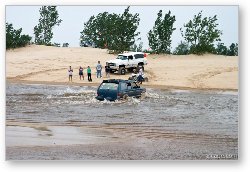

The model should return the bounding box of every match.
[96,79,146,101]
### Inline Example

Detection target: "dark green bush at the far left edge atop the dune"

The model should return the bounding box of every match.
[5,23,31,49]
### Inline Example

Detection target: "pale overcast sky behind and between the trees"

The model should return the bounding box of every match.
[6,6,238,50]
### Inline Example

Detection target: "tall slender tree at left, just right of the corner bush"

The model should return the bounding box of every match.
[34,6,62,45]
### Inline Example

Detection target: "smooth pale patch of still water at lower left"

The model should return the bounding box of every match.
[6,126,113,147]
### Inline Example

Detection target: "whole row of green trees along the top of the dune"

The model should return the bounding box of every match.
[6,6,238,56]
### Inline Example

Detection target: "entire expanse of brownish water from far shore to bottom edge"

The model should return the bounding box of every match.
[6,84,238,160]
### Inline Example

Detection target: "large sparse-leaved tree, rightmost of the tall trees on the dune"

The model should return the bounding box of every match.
[180,11,222,54]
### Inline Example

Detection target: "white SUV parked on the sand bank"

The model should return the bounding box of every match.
[106,52,148,75]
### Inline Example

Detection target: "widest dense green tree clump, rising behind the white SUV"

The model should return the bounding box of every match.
[80,7,140,53]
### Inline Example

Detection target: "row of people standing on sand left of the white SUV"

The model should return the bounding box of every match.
[68,61,110,82]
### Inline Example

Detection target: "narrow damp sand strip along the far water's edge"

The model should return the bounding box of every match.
[6,77,239,92]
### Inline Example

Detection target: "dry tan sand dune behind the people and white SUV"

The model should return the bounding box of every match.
[6,45,238,90]
